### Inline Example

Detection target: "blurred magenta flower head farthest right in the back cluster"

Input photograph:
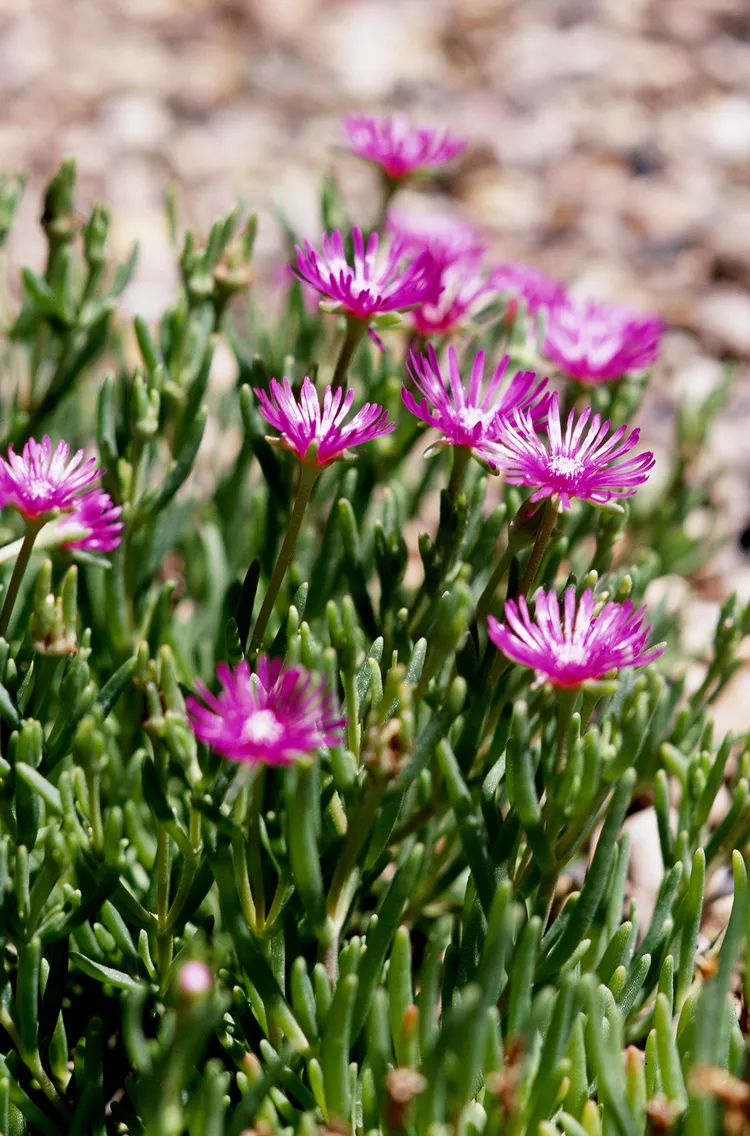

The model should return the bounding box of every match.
[544,299,664,383]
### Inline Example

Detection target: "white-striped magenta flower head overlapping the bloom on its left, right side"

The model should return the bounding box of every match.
[493,393,655,509]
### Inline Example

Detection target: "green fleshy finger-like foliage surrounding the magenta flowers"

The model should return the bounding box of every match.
[0,157,750,1136]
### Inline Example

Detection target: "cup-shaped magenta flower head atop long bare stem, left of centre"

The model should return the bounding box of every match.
[256,376,395,466]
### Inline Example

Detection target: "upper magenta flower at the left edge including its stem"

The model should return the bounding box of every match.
[0,435,99,635]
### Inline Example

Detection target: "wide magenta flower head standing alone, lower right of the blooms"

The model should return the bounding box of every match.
[489,587,664,688]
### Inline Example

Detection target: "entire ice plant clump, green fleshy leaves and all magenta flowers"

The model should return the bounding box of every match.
[0,116,750,1136]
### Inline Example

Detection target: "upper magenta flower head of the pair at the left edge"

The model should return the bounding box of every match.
[0,435,100,520]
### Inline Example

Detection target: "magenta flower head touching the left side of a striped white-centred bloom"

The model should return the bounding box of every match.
[401,346,549,471]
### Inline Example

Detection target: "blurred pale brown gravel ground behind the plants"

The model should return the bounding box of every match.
[0,0,750,728]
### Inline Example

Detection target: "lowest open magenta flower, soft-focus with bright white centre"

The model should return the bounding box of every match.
[186,655,345,766]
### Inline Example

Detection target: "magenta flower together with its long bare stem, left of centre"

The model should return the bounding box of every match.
[252,376,395,650]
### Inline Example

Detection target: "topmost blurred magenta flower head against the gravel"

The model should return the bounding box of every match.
[343,114,466,182]
